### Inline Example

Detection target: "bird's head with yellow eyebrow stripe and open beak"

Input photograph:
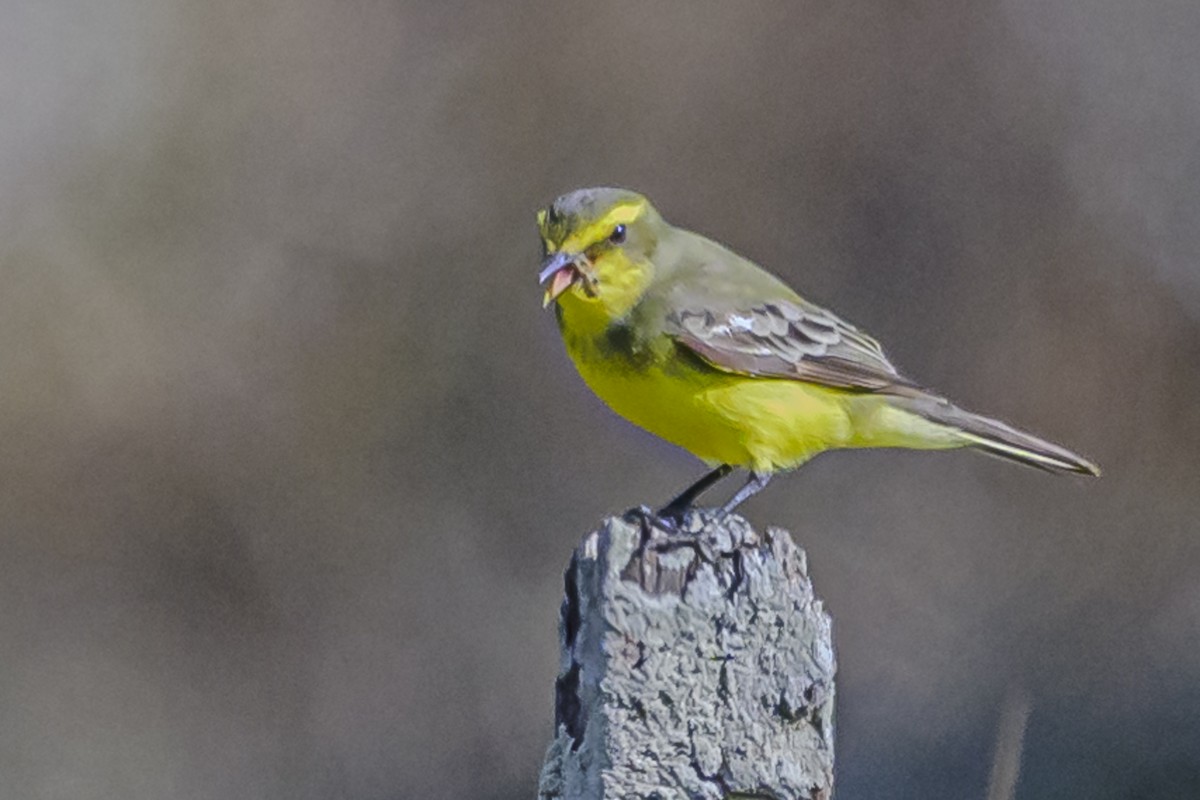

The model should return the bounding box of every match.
[538,188,666,319]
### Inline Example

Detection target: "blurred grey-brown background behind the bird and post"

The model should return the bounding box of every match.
[0,0,1200,800]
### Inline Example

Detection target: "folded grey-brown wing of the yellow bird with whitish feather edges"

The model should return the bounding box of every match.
[666,300,913,392]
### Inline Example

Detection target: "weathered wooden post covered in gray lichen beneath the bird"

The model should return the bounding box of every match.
[539,511,835,800]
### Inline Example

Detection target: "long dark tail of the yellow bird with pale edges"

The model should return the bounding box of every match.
[904,393,1100,476]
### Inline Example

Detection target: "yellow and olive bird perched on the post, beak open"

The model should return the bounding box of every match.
[538,188,1099,521]
